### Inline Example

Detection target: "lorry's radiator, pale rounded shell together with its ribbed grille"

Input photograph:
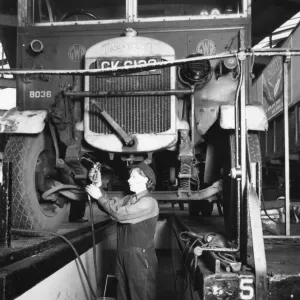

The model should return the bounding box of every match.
[84,37,177,153]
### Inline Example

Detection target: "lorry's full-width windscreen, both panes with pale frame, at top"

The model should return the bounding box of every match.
[25,0,248,26]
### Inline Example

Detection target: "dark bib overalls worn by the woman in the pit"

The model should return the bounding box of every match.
[116,216,157,300]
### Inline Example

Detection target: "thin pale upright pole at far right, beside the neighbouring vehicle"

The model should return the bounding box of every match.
[283,57,291,236]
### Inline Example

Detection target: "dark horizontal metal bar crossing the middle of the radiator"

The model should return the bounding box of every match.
[64,89,194,98]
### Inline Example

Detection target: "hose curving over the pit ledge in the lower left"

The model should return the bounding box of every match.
[12,229,97,300]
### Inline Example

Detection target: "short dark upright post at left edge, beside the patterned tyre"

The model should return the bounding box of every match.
[0,161,12,247]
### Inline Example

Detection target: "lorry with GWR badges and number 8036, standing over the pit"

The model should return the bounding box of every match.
[1,1,267,231]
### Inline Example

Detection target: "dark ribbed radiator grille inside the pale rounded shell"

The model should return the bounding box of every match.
[89,64,171,134]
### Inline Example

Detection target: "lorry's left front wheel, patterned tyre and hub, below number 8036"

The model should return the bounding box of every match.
[3,132,68,231]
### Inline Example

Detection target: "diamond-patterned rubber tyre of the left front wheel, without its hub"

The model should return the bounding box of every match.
[3,133,68,232]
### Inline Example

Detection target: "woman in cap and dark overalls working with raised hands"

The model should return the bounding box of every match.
[86,162,159,300]
